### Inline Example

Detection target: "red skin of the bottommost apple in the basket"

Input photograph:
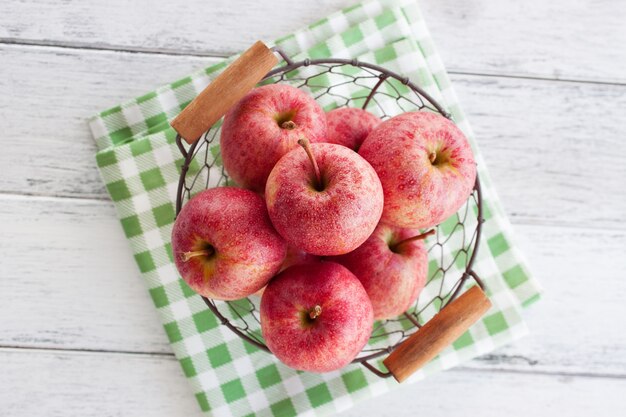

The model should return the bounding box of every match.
[261,262,374,372]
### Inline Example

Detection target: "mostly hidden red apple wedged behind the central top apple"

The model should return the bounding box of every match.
[326,107,382,151]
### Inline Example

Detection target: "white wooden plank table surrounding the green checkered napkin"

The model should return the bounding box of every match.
[0,0,626,417]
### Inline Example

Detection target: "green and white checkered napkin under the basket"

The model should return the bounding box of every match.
[85,0,540,416]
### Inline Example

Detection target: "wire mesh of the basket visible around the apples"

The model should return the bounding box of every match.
[179,61,480,361]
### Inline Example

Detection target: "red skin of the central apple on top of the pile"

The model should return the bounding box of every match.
[265,143,383,255]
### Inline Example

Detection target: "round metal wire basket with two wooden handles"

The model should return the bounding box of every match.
[172,43,488,380]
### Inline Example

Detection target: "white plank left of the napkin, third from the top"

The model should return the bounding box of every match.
[0,196,171,353]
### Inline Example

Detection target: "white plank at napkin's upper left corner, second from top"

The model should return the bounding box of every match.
[0,46,216,198]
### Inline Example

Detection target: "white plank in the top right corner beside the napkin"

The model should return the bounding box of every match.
[421,0,626,83]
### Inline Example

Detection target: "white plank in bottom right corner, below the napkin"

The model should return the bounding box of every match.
[341,370,626,417]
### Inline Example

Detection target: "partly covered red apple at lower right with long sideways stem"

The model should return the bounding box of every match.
[328,223,428,320]
